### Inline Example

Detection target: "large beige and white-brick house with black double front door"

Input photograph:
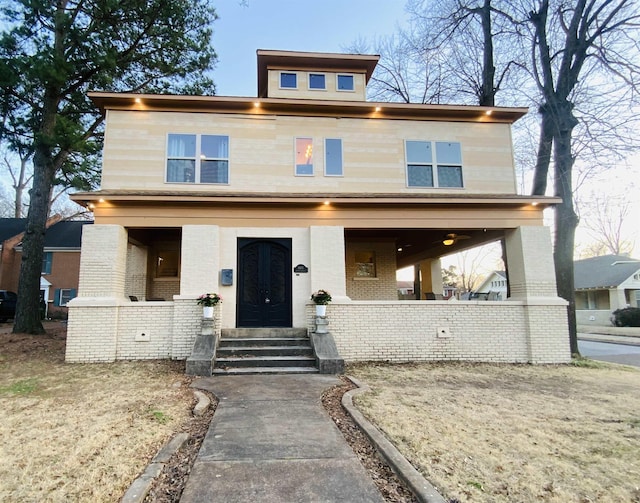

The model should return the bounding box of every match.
[66,50,570,363]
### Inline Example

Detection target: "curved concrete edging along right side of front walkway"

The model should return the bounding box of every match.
[342,376,447,503]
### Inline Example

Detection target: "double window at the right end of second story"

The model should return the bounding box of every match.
[405,140,463,187]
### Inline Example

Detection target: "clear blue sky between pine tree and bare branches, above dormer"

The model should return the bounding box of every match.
[213,0,407,96]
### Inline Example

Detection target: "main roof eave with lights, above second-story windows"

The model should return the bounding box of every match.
[88,91,528,124]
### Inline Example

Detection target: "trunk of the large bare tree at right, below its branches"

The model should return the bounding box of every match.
[553,102,579,355]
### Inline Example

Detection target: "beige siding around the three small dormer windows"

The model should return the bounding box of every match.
[268,70,367,101]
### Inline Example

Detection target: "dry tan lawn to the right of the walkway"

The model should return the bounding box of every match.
[348,364,640,503]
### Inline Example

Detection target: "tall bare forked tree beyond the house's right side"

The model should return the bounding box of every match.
[528,0,640,353]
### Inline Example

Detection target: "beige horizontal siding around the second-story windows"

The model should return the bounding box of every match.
[102,110,516,195]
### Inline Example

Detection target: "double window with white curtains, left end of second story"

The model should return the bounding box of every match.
[167,134,229,183]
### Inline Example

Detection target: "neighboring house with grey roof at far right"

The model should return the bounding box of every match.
[573,255,640,326]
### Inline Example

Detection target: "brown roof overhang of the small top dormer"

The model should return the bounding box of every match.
[256,49,380,96]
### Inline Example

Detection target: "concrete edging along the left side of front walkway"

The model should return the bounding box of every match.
[120,391,211,503]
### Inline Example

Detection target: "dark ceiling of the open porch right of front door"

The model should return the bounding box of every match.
[345,228,504,269]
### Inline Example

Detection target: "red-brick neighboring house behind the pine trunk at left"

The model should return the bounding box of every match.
[0,217,92,316]
